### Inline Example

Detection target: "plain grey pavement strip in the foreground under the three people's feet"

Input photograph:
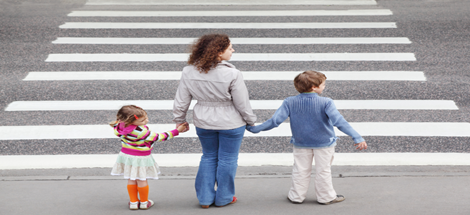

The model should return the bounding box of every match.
[0,171,470,215]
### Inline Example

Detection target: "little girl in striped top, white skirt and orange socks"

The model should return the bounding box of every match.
[110,105,188,210]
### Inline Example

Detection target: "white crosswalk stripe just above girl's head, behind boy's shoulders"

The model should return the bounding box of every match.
[5,100,459,111]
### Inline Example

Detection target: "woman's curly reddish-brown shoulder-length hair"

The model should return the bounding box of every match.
[188,34,230,73]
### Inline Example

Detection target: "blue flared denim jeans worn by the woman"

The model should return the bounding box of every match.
[195,126,245,206]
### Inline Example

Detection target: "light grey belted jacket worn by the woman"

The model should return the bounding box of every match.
[173,61,256,130]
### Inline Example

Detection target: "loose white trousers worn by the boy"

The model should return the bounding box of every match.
[288,147,336,203]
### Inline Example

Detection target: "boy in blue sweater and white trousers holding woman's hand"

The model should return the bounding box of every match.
[247,71,367,205]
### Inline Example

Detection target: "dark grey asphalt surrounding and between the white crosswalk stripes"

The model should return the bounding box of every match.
[0,0,470,155]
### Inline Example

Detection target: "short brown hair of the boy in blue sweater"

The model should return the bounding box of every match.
[294,70,326,93]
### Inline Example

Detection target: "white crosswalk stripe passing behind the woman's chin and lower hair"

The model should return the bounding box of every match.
[46,53,416,62]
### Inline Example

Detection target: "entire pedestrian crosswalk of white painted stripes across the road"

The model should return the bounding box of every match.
[0,0,470,169]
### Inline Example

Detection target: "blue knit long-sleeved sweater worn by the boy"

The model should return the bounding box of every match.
[247,93,364,148]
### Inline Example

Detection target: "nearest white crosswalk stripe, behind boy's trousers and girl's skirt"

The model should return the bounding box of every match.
[0,153,470,170]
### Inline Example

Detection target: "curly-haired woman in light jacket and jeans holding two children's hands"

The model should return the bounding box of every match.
[173,34,256,208]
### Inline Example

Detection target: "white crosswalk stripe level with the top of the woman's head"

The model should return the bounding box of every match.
[52,37,411,45]
